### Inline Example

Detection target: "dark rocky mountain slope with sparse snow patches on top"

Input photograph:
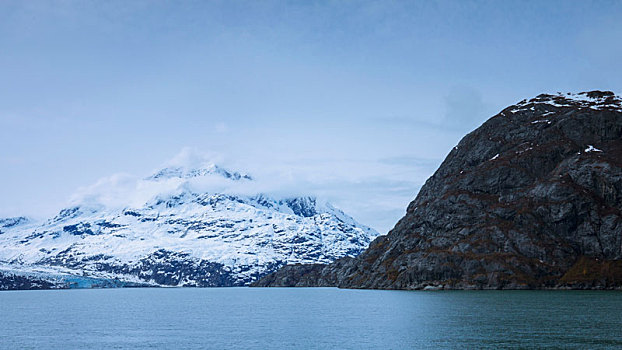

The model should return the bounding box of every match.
[256,91,622,289]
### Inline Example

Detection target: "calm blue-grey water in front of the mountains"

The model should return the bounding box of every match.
[0,288,622,349]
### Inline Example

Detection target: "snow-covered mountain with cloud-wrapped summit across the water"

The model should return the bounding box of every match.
[0,154,378,287]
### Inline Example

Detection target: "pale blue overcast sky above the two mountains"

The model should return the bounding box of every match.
[0,0,622,233]
